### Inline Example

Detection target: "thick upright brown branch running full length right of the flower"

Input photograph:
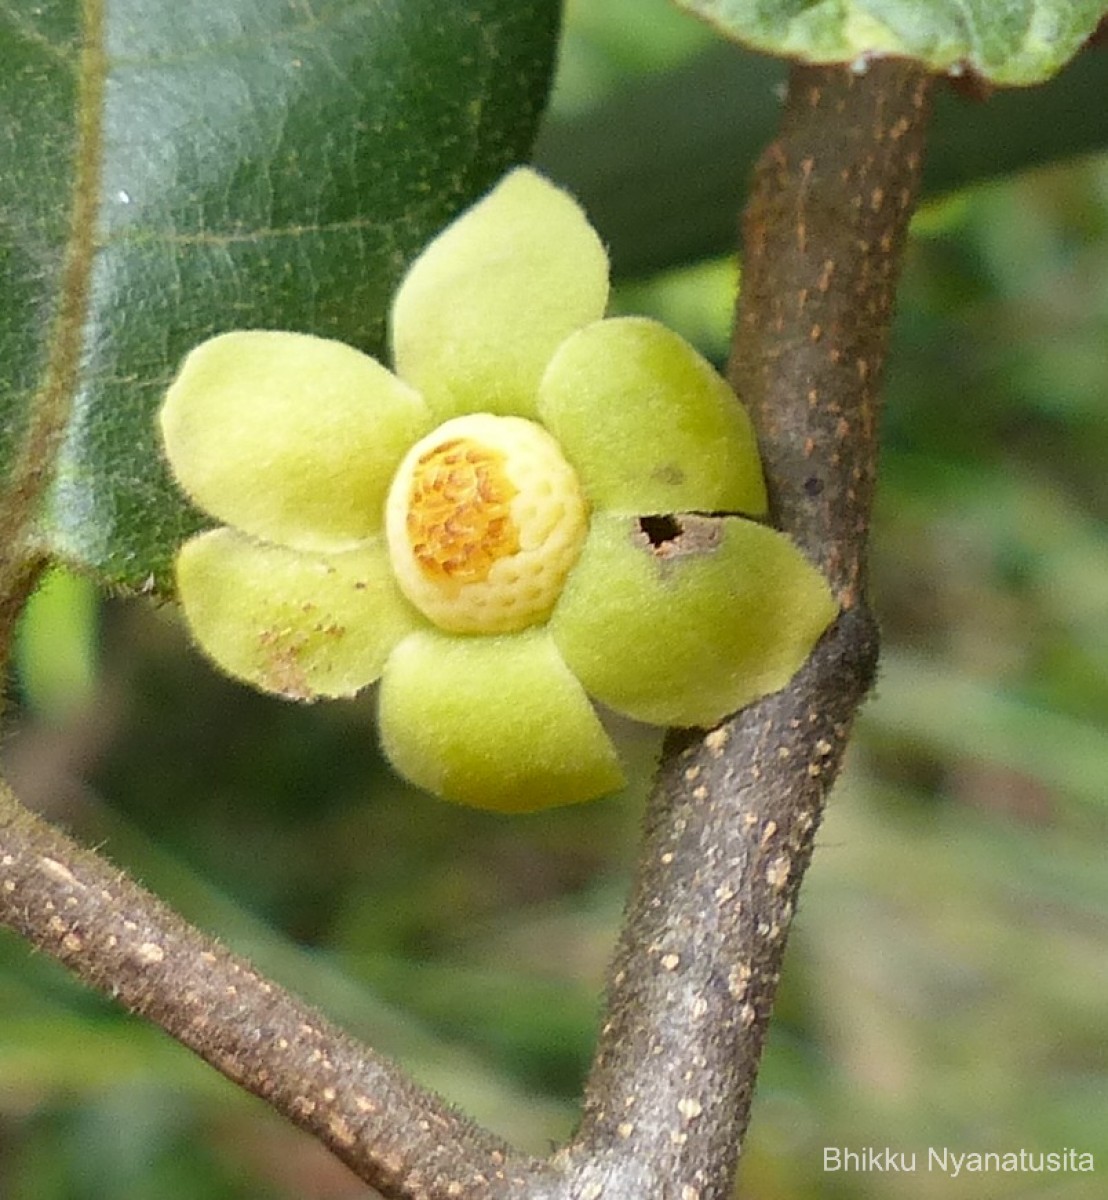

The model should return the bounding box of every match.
[564,62,929,1200]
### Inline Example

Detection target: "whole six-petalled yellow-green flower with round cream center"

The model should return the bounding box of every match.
[153,168,836,811]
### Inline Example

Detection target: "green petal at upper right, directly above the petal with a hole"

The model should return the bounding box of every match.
[539,317,766,516]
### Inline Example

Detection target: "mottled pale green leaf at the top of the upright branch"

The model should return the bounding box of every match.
[677,0,1108,85]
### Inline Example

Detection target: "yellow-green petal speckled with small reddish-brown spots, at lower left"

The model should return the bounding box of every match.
[176,529,423,700]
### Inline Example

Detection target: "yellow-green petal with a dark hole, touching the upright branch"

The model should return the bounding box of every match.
[549,514,836,726]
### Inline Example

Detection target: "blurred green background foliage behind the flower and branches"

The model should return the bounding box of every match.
[0,0,1108,1200]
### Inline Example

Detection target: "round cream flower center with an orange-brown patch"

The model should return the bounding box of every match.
[385,413,588,634]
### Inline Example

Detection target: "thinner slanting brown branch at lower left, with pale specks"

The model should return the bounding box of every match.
[0,784,544,1200]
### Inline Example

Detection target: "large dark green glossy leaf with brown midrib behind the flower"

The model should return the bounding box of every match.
[0,0,561,587]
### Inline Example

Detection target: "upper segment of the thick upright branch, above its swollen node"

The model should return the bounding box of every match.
[731,62,932,595]
